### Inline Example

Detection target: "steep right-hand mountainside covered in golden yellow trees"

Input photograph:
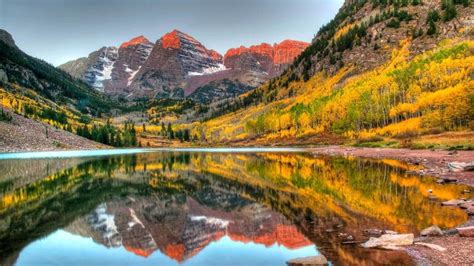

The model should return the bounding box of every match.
[190,0,474,147]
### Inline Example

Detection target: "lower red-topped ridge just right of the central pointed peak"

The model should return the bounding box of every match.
[185,40,309,103]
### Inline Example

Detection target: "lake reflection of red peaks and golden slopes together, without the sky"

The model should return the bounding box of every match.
[0,153,466,263]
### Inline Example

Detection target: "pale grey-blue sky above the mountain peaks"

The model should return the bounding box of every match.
[0,0,344,66]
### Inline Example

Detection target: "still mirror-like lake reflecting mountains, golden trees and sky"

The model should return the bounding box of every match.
[0,149,467,266]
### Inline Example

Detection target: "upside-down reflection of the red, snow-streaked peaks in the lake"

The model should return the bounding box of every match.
[66,195,313,262]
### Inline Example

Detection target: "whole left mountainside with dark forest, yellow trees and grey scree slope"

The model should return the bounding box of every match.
[0,30,120,152]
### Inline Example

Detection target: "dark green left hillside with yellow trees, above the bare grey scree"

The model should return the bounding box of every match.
[0,30,138,150]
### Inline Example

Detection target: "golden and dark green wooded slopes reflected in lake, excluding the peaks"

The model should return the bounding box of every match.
[0,152,466,262]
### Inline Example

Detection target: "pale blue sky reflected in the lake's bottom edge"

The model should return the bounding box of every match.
[16,230,319,266]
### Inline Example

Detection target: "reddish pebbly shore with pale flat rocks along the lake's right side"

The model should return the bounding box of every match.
[312,146,474,265]
